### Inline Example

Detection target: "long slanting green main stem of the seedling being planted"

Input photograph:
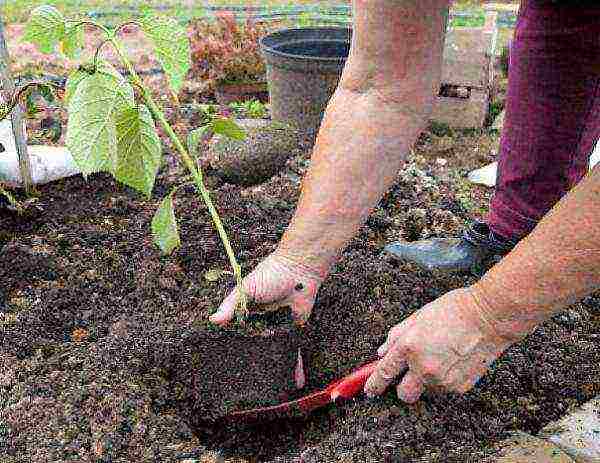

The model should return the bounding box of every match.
[109,34,248,324]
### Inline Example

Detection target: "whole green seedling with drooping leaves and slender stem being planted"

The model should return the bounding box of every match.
[9,6,247,322]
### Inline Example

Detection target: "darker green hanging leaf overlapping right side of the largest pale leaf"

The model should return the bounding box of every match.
[115,105,161,198]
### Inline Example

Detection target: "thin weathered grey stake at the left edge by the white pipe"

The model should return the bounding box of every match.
[0,17,32,193]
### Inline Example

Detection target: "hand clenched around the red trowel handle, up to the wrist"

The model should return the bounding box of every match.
[365,288,515,403]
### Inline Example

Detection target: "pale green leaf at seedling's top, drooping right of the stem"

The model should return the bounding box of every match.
[140,11,191,93]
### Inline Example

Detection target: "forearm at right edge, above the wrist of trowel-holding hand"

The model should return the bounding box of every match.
[473,169,600,339]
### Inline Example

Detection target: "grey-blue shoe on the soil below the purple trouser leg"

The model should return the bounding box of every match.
[383,221,517,272]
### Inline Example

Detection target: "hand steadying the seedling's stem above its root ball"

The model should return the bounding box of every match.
[210,252,324,326]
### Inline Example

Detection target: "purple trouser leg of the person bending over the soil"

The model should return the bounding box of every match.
[487,0,600,239]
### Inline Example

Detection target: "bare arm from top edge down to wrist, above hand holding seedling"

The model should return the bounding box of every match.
[279,0,447,274]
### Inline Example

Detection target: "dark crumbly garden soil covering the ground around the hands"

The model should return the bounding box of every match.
[0,122,600,463]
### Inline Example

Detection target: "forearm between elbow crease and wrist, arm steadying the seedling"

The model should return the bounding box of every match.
[279,90,422,274]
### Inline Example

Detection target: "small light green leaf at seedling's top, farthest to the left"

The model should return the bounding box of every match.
[23,5,65,53]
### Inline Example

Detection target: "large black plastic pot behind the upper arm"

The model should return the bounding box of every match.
[260,27,352,149]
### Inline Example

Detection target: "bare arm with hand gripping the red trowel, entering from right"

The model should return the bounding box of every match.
[365,168,600,402]
